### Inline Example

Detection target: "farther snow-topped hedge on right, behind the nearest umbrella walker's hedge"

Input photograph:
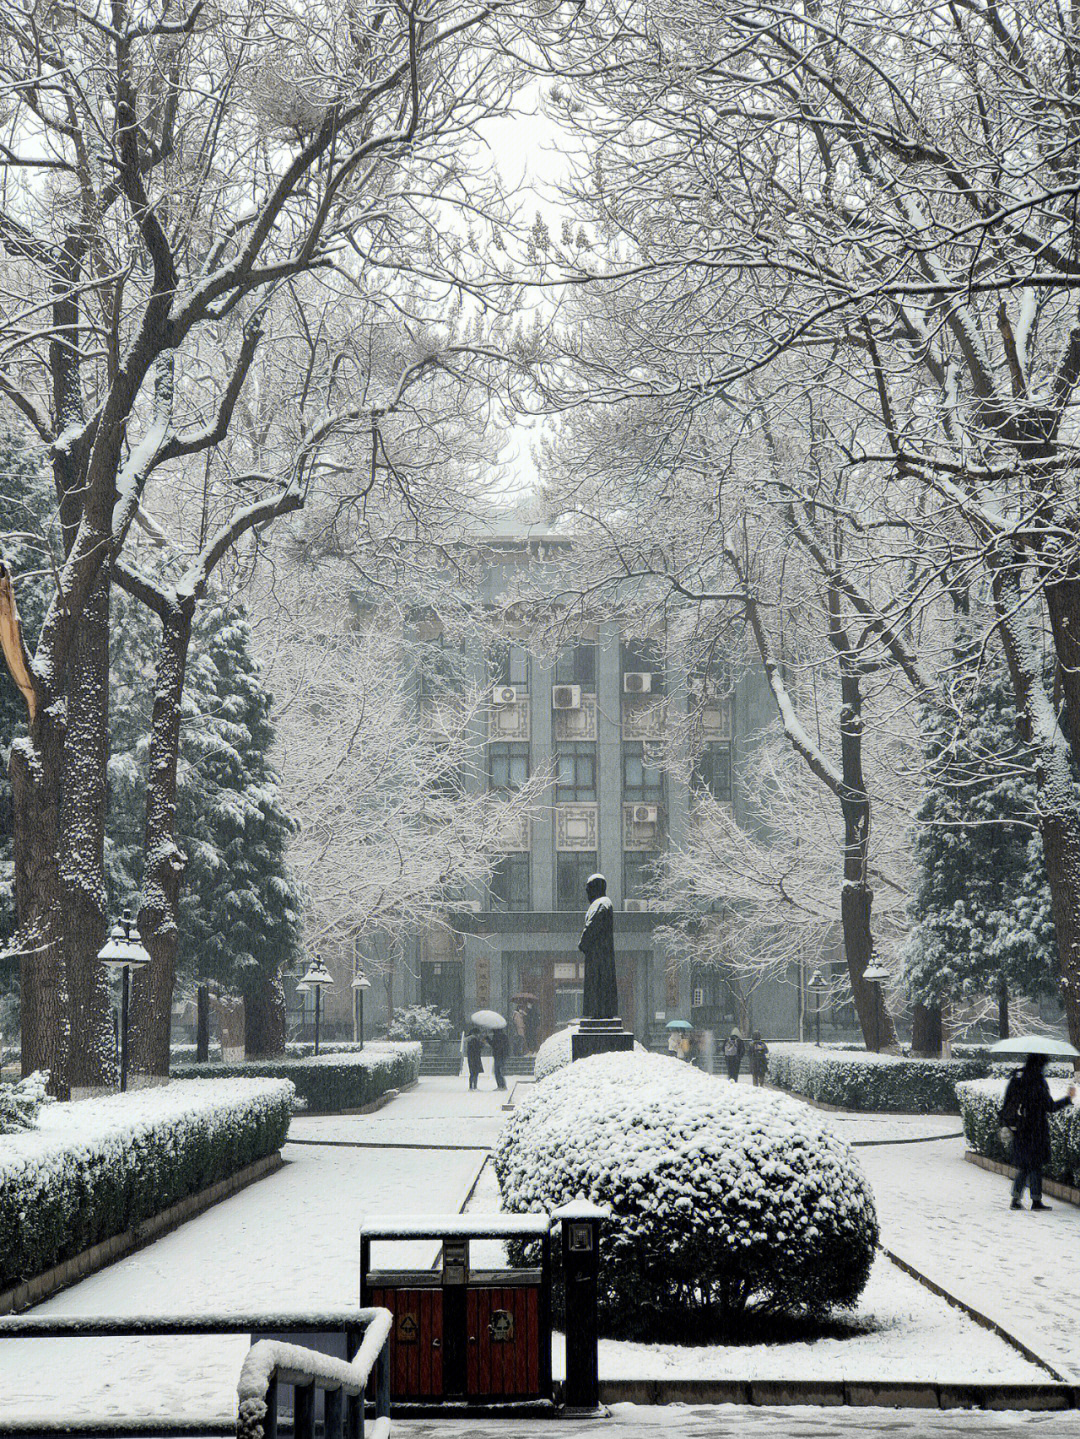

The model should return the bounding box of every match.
[768,1045,988,1114]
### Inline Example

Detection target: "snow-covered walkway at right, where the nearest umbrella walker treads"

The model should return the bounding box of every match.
[859,1140,1080,1381]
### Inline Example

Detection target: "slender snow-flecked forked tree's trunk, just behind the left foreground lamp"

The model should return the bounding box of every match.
[131,602,194,1078]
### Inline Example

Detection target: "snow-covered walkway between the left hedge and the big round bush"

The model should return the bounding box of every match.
[0,1079,503,1429]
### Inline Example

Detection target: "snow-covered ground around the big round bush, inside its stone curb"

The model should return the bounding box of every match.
[469,1145,1048,1384]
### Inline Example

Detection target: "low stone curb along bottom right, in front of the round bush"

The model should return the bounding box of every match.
[600,1379,1080,1410]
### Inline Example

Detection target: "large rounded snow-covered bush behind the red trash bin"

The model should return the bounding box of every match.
[495,1053,877,1340]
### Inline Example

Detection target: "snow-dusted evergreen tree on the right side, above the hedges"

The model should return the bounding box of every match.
[903,663,1057,1024]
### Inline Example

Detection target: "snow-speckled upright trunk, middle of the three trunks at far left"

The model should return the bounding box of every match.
[60,566,115,1089]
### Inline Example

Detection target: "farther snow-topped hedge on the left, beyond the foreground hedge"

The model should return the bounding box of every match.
[173,1043,423,1114]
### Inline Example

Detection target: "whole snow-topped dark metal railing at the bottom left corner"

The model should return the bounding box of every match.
[0,1308,393,1439]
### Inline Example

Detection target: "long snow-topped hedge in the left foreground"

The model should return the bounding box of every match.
[0,1079,292,1289]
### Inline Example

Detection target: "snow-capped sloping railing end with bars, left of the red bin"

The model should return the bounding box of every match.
[236,1308,393,1439]
